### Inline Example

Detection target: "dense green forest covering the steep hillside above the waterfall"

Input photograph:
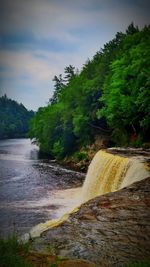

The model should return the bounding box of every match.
[30,23,150,158]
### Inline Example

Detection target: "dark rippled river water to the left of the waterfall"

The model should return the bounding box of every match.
[0,139,84,236]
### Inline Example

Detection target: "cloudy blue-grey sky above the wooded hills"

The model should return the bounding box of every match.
[0,0,150,111]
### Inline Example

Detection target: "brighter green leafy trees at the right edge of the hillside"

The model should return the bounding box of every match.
[97,24,150,146]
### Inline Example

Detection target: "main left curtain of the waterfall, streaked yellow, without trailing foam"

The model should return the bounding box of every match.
[81,150,129,203]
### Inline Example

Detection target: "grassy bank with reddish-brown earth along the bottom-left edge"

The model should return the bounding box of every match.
[0,233,61,267]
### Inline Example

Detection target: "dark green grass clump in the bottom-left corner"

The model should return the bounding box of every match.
[0,235,32,267]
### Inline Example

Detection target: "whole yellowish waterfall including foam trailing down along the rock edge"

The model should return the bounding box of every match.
[23,150,150,240]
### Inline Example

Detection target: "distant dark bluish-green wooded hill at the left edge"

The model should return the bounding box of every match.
[0,95,34,139]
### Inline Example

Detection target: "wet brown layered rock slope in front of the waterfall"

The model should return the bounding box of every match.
[33,178,150,267]
